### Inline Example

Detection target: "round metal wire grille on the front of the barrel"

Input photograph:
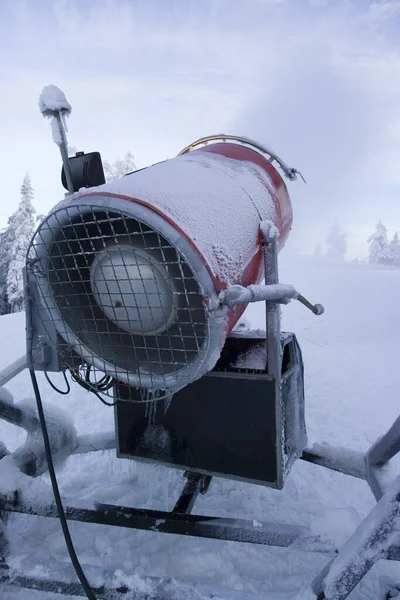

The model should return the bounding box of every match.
[28,204,207,390]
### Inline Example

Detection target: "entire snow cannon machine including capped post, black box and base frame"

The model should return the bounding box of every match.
[0,86,400,600]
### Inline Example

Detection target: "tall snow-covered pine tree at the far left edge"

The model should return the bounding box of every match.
[6,173,36,312]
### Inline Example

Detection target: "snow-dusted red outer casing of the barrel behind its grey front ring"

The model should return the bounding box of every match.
[73,142,292,333]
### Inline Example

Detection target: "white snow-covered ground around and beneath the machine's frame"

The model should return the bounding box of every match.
[0,256,400,600]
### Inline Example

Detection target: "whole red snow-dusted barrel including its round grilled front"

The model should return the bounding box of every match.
[35,135,295,390]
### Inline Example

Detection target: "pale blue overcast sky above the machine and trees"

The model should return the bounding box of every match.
[0,0,400,256]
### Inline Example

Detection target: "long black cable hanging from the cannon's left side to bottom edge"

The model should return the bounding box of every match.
[29,369,96,600]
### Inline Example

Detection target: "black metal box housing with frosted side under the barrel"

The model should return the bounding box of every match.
[115,334,306,489]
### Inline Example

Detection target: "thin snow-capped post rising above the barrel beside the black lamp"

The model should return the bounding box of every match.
[39,85,74,194]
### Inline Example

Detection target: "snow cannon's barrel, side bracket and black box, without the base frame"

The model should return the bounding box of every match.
[26,135,320,488]
